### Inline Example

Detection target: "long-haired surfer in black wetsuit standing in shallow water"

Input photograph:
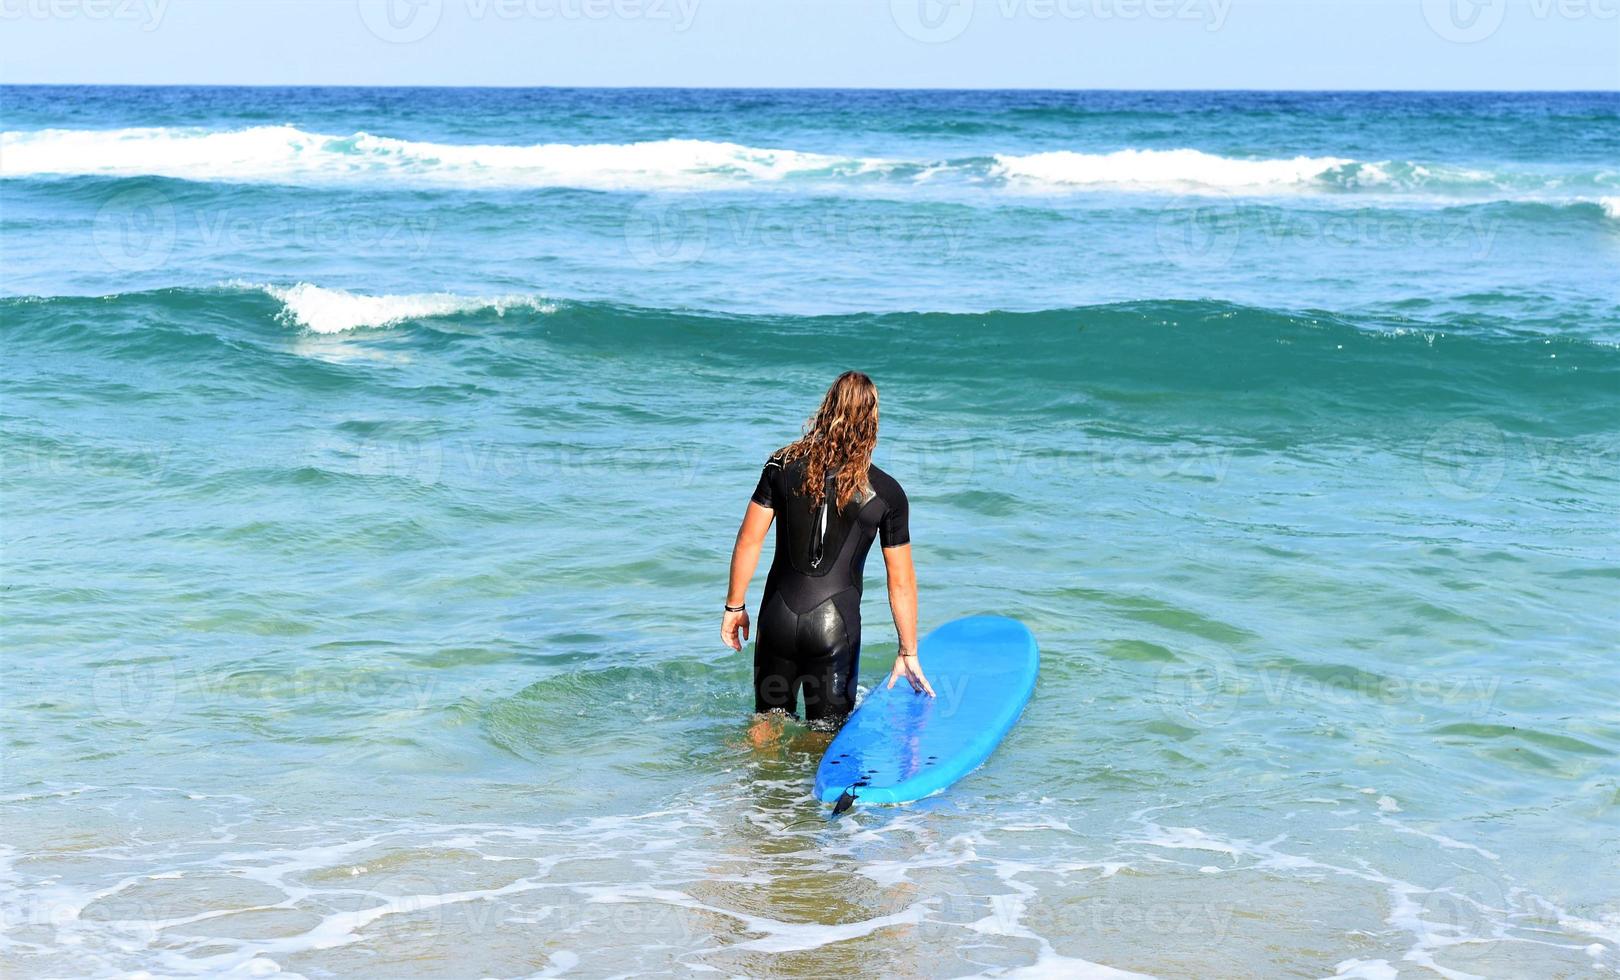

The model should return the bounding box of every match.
[719,371,933,727]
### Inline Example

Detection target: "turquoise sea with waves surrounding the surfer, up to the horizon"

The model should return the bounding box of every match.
[0,87,1620,977]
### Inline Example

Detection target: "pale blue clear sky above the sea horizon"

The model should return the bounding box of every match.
[0,0,1620,89]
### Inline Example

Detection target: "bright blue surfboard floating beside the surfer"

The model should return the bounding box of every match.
[815,616,1040,805]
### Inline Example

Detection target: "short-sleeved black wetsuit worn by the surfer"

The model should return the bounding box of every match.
[753,455,910,721]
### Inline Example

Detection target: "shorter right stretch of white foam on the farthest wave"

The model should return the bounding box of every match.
[995,149,1354,191]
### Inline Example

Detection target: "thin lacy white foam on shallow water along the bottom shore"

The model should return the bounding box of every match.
[0,779,1600,980]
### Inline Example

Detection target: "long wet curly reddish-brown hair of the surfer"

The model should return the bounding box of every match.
[782,371,878,510]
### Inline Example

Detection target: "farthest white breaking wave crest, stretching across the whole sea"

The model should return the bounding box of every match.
[0,125,1620,202]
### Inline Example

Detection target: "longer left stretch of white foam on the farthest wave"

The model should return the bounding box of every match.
[0,125,885,190]
